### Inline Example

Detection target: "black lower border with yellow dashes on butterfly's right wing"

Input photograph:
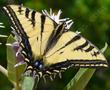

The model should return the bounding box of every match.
[46,59,107,71]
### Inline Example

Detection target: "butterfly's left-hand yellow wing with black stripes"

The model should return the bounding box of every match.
[4,5,54,58]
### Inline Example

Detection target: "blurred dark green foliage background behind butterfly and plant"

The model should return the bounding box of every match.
[0,0,110,90]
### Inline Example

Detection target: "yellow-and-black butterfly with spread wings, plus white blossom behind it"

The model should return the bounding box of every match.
[3,5,108,77]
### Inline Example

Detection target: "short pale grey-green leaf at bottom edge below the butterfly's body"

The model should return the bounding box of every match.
[22,76,35,90]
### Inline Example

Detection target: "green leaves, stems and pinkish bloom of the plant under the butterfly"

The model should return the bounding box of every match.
[0,13,107,90]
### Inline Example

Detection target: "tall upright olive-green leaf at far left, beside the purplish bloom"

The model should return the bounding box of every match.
[7,36,16,82]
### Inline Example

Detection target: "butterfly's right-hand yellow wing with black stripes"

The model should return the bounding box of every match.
[45,31,107,67]
